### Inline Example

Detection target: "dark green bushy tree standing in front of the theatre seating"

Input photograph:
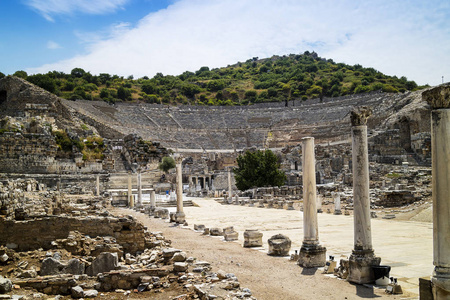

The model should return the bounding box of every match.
[233,150,286,191]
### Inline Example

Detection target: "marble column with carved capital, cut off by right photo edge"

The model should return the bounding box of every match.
[422,83,450,300]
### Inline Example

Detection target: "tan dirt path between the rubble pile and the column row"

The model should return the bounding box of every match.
[111,208,407,300]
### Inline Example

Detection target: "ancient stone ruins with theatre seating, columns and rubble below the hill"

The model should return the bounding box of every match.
[0,76,450,299]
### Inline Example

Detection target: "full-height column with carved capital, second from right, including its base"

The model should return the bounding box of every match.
[347,107,381,284]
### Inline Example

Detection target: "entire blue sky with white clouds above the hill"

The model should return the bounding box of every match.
[0,0,450,85]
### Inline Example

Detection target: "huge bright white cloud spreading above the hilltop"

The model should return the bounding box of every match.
[30,0,450,84]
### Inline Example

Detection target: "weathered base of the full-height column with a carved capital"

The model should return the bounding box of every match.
[347,250,381,284]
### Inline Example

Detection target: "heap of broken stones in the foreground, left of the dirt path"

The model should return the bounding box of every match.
[0,225,255,299]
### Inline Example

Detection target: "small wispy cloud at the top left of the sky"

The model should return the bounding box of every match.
[25,0,129,21]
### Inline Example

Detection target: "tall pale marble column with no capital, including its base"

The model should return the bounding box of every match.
[297,137,327,268]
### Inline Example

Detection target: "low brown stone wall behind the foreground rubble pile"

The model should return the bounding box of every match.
[0,216,145,253]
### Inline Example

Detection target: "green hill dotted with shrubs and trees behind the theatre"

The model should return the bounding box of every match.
[0,51,423,105]
